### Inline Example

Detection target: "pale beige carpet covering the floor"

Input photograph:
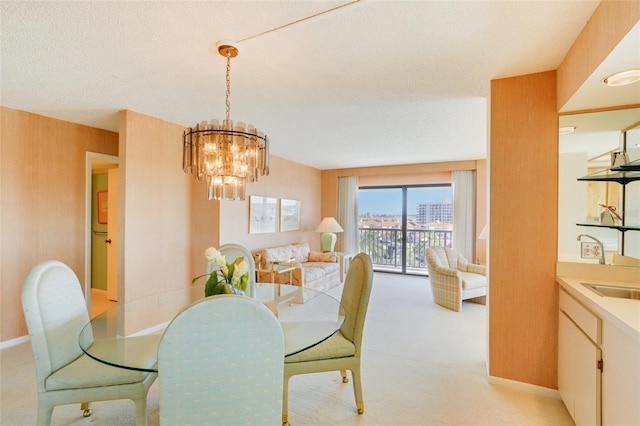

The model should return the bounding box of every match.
[0,273,573,426]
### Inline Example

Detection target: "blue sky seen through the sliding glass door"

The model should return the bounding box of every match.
[358,187,453,215]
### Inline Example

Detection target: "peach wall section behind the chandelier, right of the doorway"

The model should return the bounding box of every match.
[118,111,218,301]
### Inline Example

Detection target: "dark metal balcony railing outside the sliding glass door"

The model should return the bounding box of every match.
[358,228,452,275]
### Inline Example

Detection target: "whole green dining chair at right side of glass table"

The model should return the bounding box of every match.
[282,253,373,424]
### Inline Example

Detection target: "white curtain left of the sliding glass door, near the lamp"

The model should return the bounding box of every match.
[338,176,358,253]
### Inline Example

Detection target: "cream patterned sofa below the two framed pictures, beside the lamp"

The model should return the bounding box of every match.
[253,243,340,292]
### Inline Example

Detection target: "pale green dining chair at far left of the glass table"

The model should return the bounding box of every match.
[22,260,157,425]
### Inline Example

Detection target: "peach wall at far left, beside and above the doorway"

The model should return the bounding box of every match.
[0,107,118,341]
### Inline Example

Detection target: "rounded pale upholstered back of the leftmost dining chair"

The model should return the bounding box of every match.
[22,260,89,392]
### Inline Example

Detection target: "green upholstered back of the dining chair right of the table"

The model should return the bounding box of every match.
[340,253,373,355]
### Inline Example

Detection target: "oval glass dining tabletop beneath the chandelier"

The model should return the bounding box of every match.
[78,284,345,372]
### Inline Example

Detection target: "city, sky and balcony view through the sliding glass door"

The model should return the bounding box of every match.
[358,185,453,275]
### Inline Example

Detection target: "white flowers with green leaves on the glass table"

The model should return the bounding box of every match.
[191,247,249,297]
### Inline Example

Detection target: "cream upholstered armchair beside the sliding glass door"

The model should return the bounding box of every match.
[427,247,487,312]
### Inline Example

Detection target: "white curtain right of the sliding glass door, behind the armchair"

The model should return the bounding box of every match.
[452,170,476,262]
